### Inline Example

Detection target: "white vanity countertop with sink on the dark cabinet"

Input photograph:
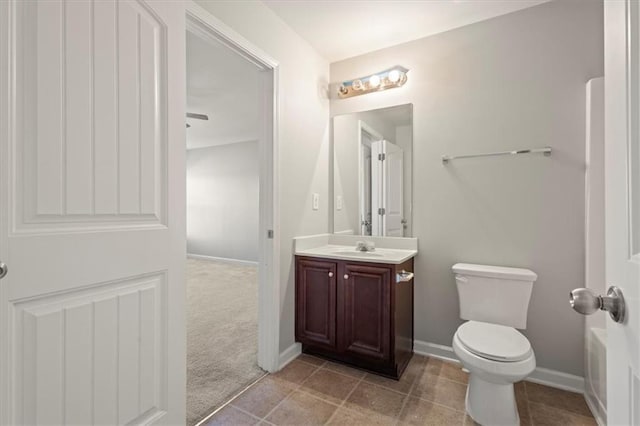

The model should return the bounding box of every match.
[295,244,418,265]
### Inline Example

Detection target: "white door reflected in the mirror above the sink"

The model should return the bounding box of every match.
[371,140,404,237]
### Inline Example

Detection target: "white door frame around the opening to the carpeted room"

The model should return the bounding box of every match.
[184,1,280,372]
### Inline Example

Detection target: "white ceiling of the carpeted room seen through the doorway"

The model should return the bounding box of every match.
[186,32,261,149]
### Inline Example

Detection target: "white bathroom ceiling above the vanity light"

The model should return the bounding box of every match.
[263,0,550,62]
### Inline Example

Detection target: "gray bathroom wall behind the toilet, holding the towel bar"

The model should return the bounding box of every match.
[331,0,604,375]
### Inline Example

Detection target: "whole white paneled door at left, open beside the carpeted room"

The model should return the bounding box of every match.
[0,0,185,425]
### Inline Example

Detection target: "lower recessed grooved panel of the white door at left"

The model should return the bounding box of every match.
[13,274,166,424]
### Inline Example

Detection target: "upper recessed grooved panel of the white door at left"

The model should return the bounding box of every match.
[17,1,167,232]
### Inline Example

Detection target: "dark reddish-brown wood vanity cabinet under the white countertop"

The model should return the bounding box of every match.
[296,256,413,378]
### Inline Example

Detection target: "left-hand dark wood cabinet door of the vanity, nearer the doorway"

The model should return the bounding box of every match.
[296,259,336,348]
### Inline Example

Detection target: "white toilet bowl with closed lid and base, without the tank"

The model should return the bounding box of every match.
[453,321,536,426]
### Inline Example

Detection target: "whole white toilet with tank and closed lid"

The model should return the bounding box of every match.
[452,263,538,426]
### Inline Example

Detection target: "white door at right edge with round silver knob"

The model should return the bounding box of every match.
[605,0,640,426]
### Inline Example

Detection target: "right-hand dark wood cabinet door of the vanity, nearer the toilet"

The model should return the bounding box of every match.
[341,263,392,359]
